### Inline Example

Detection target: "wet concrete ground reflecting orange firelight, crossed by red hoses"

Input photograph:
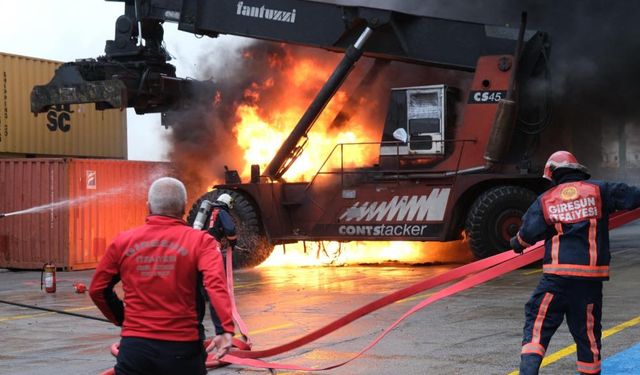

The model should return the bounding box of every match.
[0,224,640,375]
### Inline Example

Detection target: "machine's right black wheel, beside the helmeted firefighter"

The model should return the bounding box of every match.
[466,186,536,259]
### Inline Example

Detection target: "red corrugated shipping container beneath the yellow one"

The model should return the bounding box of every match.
[0,159,170,270]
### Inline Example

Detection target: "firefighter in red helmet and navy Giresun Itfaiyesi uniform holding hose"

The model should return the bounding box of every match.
[511,151,640,375]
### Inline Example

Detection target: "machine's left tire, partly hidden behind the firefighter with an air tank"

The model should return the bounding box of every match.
[187,189,273,269]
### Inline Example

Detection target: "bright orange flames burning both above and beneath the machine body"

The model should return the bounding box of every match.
[230,47,470,267]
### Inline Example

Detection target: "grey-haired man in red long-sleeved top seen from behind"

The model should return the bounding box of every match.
[89,177,234,375]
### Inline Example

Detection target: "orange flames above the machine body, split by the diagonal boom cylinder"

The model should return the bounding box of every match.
[234,45,381,181]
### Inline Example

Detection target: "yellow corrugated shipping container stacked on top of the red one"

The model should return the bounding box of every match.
[0,53,127,159]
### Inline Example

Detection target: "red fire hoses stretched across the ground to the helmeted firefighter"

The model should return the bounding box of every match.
[102,209,640,375]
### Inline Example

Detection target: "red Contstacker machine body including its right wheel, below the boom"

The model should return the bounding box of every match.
[204,55,546,268]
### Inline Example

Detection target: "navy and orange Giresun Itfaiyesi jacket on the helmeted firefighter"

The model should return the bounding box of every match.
[517,180,640,280]
